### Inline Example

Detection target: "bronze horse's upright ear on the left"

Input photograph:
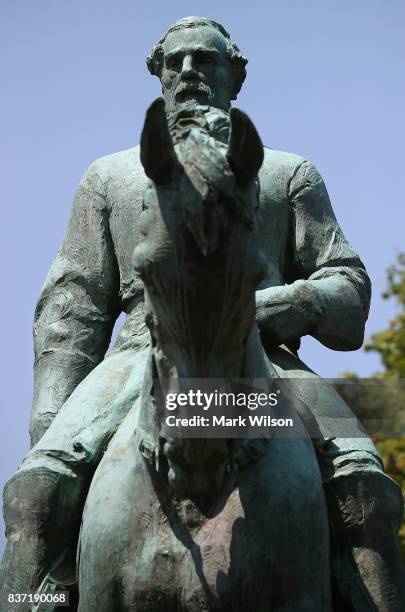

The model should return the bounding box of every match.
[141,98,178,185]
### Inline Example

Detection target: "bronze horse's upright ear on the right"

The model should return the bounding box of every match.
[227,108,264,186]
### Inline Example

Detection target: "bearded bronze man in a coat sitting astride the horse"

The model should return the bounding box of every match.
[1,17,405,612]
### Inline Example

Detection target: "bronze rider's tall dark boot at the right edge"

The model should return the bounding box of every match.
[325,472,405,612]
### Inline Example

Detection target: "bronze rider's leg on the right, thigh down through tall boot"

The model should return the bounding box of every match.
[270,347,405,612]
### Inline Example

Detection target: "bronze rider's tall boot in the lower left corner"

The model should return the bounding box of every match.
[0,466,87,612]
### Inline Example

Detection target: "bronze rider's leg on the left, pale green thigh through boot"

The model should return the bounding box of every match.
[0,349,148,612]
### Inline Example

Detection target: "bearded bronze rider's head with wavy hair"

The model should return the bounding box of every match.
[146,17,247,111]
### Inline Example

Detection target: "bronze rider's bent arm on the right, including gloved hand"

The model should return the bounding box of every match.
[256,161,371,350]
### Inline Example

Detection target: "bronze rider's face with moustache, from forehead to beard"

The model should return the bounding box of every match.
[160,26,233,111]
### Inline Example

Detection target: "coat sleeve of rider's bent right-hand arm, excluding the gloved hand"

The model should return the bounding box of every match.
[288,161,371,350]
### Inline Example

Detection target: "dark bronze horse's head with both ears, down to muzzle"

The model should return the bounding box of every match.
[134,99,267,494]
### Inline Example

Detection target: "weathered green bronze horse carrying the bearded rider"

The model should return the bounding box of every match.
[78,99,332,612]
